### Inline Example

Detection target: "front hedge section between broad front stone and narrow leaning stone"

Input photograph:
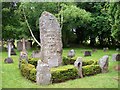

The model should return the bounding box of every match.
[51,65,78,83]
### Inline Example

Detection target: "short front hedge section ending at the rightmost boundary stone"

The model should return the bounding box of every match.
[82,65,101,76]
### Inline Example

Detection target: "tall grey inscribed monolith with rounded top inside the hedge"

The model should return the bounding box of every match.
[39,11,62,67]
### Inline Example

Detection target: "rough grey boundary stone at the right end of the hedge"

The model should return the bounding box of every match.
[98,55,109,73]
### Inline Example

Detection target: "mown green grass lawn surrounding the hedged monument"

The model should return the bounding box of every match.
[0,48,118,88]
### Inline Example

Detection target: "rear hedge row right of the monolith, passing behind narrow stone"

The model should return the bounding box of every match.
[63,57,98,66]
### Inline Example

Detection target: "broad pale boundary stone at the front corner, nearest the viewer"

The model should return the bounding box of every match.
[36,60,51,85]
